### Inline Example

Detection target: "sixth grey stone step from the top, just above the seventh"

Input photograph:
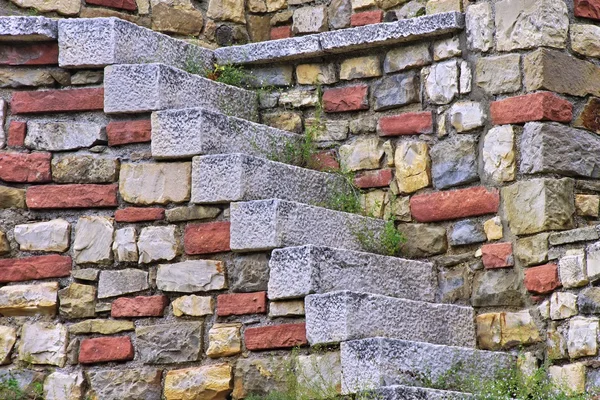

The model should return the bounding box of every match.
[268,245,437,302]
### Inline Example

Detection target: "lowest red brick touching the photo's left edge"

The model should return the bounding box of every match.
[0,254,72,283]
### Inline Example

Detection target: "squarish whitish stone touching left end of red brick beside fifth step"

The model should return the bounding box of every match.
[138,225,180,264]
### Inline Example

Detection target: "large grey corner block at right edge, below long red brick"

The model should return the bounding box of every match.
[520,122,600,178]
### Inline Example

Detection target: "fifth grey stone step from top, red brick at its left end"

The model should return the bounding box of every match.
[230,199,385,252]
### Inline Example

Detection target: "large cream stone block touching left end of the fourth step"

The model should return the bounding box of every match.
[119,163,192,205]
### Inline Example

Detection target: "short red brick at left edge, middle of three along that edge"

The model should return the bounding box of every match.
[0,153,52,183]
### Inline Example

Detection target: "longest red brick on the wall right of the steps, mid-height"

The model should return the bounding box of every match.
[410,186,500,222]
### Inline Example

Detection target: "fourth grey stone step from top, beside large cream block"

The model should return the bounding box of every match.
[191,153,353,205]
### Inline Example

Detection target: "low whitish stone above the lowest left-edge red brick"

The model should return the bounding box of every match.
[14,219,71,252]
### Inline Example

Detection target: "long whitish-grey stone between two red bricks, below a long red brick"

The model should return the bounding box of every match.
[25,121,107,151]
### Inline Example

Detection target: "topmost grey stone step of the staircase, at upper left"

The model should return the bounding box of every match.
[58,17,214,70]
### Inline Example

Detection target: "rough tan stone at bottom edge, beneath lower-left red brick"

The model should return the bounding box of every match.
[86,367,162,400]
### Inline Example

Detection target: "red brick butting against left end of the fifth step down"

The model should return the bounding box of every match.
[183,222,231,254]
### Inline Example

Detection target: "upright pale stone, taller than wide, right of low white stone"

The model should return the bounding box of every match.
[73,217,114,264]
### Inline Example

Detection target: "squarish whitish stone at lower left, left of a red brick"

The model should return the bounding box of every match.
[19,322,67,368]
